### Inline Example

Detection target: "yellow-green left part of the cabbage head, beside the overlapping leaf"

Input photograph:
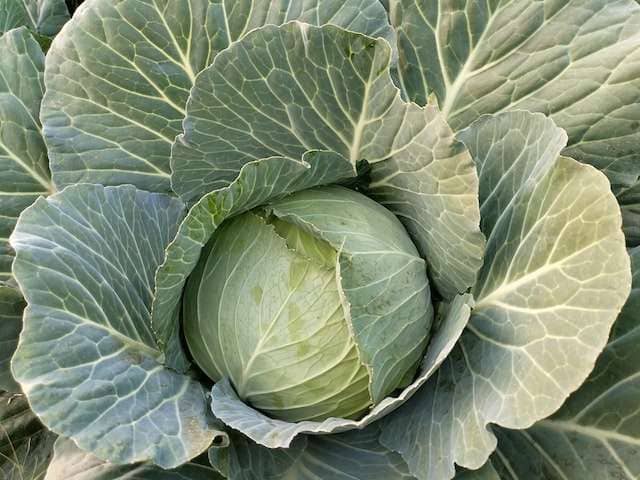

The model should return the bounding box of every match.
[183,186,428,422]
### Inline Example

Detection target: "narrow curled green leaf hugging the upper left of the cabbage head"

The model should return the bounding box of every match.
[152,152,356,369]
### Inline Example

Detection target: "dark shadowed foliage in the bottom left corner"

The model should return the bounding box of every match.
[0,392,55,480]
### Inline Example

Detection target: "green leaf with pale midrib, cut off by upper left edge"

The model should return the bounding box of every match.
[0,28,52,281]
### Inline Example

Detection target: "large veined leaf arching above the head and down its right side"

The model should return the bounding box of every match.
[171,22,483,298]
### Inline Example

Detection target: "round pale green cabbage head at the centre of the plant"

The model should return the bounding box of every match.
[183,187,432,422]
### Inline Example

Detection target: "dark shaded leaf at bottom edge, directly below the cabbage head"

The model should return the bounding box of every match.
[209,425,414,480]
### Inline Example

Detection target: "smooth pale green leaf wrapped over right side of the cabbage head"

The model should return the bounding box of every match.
[267,186,433,404]
